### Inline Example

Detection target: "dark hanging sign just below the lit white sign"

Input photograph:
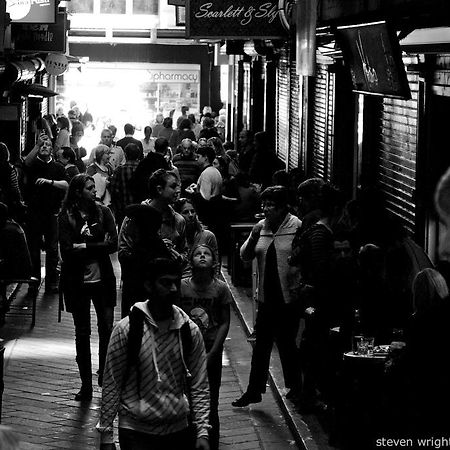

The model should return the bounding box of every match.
[11,13,66,53]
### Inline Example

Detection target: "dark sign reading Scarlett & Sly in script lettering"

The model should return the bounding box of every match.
[186,0,287,39]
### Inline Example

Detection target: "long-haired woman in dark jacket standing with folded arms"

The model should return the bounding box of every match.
[58,174,117,401]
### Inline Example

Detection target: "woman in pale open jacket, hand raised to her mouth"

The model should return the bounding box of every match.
[232,186,301,407]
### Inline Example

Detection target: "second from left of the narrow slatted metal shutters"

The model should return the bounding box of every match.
[288,60,300,169]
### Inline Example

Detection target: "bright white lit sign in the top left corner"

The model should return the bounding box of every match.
[6,0,56,23]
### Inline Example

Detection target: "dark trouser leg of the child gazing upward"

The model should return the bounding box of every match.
[208,349,223,450]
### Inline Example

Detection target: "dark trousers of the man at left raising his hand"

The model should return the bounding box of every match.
[26,211,58,284]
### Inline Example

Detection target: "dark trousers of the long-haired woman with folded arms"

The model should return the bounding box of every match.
[72,282,114,386]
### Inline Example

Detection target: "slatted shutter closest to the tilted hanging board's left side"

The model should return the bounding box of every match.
[309,64,335,181]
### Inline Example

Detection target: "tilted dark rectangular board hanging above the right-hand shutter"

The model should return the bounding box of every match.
[336,22,411,100]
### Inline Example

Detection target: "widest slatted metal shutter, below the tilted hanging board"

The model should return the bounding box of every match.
[378,73,419,231]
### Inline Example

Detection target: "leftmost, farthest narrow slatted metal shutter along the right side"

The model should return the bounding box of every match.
[276,53,289,163]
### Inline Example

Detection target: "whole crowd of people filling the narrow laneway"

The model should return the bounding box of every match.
[0,103,450,450]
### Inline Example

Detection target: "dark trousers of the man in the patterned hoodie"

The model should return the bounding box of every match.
[119,428,196,450]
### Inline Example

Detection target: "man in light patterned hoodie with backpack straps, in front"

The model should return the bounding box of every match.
[97,258,209,450]
